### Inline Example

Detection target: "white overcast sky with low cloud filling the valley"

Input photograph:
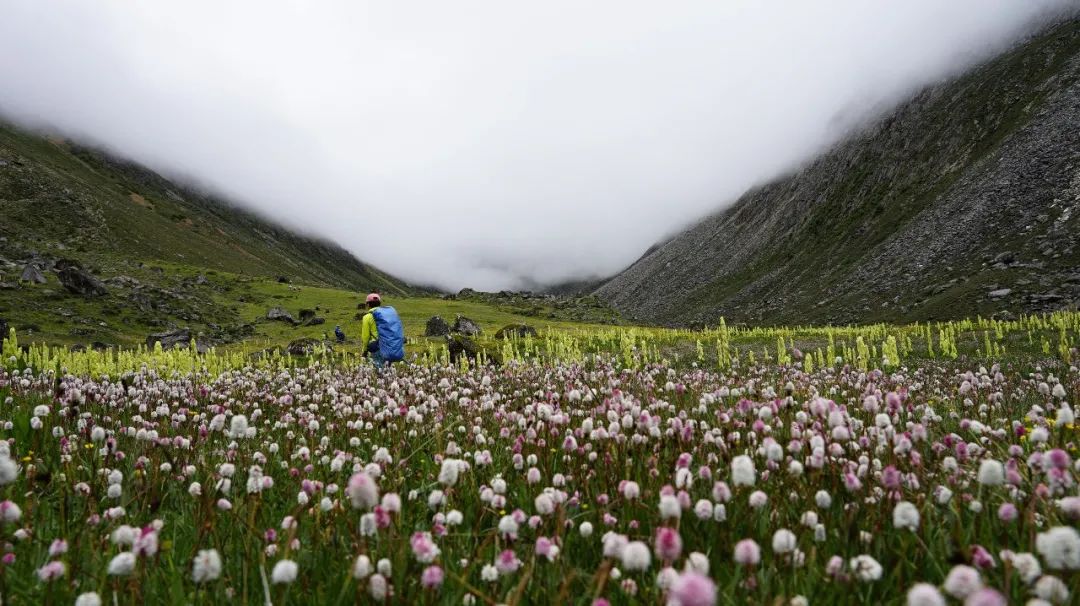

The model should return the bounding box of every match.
[0,0,1071,289]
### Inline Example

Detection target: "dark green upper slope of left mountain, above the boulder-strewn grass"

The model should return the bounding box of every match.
[0,123,408,293]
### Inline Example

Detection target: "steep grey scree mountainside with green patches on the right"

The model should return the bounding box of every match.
[595,17,1080,325]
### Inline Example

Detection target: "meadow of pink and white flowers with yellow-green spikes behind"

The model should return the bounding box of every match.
[0,314,1080,606]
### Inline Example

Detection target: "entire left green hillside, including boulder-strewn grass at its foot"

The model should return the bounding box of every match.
[0,118,412,348]
